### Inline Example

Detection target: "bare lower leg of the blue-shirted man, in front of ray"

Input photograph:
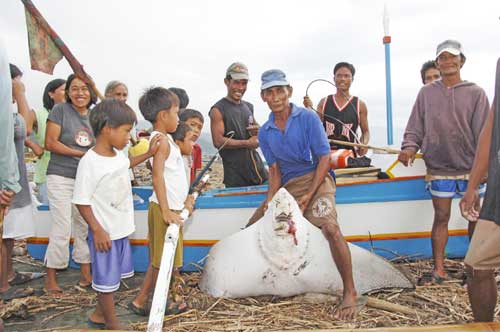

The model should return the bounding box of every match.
[321,223,358,319]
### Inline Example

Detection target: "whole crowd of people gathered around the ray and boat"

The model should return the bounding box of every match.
[0,35,500,329]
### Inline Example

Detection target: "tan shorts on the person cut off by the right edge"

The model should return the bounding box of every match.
[464,219,500,270]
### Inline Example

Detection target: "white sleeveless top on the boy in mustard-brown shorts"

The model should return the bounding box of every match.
[149,131,189,210]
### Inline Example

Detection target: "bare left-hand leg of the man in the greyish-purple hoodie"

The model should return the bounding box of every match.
[431,197,451,278]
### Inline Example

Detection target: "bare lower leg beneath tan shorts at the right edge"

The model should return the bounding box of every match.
[466,265,498,322]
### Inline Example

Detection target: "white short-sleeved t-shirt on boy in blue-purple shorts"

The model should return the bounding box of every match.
[72,149,135,240]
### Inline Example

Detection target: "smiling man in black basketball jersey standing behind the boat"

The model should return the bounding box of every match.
[304,62,370,168]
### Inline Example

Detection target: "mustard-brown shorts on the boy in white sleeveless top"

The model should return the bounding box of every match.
[148,202,184,269]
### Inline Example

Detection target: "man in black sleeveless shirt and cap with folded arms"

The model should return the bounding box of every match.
[209,62,268,188]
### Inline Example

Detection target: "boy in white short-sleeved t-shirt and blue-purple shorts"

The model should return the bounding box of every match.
[72,99,158,330]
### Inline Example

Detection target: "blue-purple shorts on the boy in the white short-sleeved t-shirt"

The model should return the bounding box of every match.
[87,230,134,293]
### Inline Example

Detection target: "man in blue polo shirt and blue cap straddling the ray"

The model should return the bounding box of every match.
[249,69,366,319]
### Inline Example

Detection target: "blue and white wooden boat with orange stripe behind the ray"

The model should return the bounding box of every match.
[28,154,469,271]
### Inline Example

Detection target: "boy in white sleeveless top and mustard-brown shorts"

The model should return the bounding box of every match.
[129,87,193,316]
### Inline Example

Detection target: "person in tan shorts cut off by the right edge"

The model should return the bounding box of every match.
[460,59,500,322]
